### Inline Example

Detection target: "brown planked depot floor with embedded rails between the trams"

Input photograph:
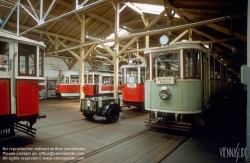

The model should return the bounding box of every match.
[0,101,186,163]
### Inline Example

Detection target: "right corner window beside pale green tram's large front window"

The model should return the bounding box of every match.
[184,49,201,79]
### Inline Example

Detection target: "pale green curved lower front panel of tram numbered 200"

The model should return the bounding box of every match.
[145,81,203,113]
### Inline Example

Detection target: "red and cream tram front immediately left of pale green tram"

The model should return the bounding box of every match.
[121,63,146,108]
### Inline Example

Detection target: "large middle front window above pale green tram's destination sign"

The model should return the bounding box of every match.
[153,52,180,78]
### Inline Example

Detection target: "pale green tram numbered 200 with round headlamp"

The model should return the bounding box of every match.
[144,41,228,130]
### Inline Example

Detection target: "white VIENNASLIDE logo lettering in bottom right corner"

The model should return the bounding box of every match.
[219,143,247,162]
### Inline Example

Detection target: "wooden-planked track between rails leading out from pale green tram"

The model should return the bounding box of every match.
[67,128,187,163]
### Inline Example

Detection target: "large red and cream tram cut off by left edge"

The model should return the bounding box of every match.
[0,31,45,137]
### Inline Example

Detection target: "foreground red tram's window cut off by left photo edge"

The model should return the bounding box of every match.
[0,41,9,72]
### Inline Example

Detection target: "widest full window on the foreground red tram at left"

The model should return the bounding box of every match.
[18,43,37,76]
